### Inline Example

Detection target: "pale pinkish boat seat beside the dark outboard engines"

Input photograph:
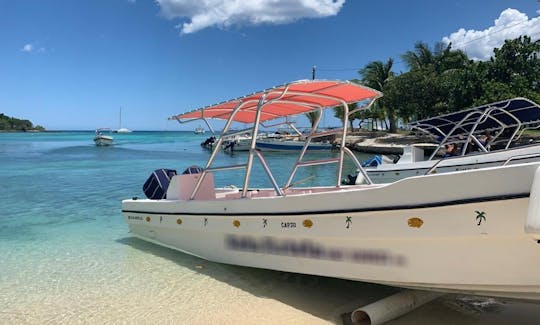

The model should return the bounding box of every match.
[167,173,216,201]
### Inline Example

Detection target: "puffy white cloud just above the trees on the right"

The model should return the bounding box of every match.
[442,8,540,61]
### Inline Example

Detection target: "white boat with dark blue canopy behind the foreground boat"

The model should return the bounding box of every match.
[347,98,540,184]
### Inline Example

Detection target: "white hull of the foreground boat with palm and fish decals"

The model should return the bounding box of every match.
[122,164,540,300]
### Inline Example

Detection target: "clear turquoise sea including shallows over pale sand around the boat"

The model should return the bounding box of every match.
[0,132,540,324]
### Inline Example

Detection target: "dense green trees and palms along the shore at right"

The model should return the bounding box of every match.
[322,36,540,132]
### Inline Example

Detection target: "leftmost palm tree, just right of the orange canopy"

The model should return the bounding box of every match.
[358,58,397,132]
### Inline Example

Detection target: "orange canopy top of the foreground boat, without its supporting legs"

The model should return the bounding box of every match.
[170,80,382,123]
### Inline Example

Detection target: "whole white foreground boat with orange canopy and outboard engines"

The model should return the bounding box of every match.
[122,80,540,300]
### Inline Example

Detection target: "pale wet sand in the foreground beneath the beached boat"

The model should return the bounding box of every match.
[5,237,540,325]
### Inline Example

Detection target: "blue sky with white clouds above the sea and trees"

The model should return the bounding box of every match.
[0,0,540,130]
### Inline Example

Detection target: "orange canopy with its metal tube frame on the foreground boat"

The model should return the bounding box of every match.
[169,80,382,200]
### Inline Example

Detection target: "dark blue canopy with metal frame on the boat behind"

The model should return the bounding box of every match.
[409,97,540,160]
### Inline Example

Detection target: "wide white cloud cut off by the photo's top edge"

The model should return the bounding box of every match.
[156,0,345,34]
